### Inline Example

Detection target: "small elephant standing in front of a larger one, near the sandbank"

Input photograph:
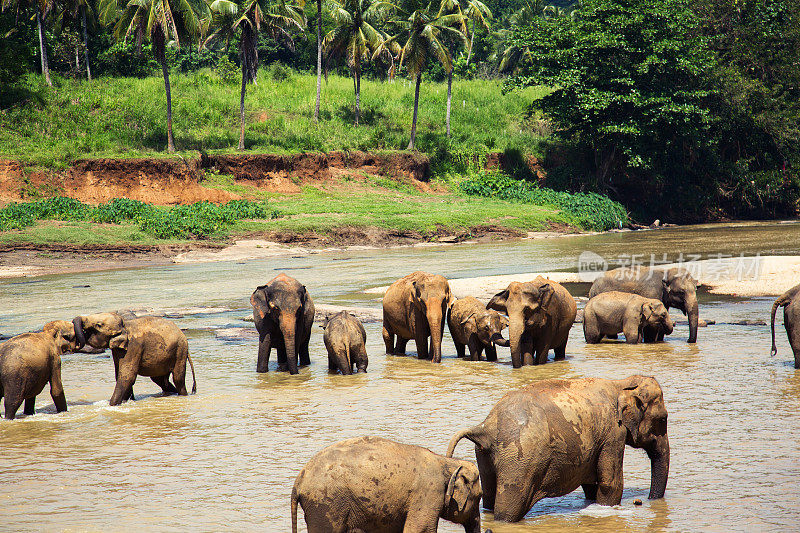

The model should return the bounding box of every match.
[583,291,673,344]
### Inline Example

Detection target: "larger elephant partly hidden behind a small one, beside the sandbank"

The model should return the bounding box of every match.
[589,267,700,343]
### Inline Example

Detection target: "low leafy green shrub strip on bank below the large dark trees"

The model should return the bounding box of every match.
[459,172,628,231]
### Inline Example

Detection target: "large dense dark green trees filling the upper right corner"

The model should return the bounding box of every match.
[506,0,800,221]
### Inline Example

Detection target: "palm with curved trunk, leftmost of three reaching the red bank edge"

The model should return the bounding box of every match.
[108,0,209,153]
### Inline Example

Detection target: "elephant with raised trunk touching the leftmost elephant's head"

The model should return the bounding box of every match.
[72,313,197,406]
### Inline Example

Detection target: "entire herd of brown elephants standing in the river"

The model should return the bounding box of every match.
[0,268,800,533]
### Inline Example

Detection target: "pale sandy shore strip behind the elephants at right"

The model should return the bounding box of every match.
[364,256,800,300]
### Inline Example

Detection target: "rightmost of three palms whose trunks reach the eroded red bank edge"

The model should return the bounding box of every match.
[388,0,464,150]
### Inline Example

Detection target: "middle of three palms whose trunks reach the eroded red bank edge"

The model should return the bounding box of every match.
[211,0,305,150]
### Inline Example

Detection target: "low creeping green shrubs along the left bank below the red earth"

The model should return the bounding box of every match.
[0,196,278,239]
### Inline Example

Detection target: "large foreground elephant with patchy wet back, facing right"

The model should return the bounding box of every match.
[447,376,669,522]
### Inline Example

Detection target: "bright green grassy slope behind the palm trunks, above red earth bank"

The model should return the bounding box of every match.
[0,69,546,168]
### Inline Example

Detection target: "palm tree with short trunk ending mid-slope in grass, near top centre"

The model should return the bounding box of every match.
[322,0,389,126]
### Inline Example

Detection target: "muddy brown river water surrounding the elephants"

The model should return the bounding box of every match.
[0,224,800,533]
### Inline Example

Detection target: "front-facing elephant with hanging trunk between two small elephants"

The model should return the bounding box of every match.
[383,272,453,363]
